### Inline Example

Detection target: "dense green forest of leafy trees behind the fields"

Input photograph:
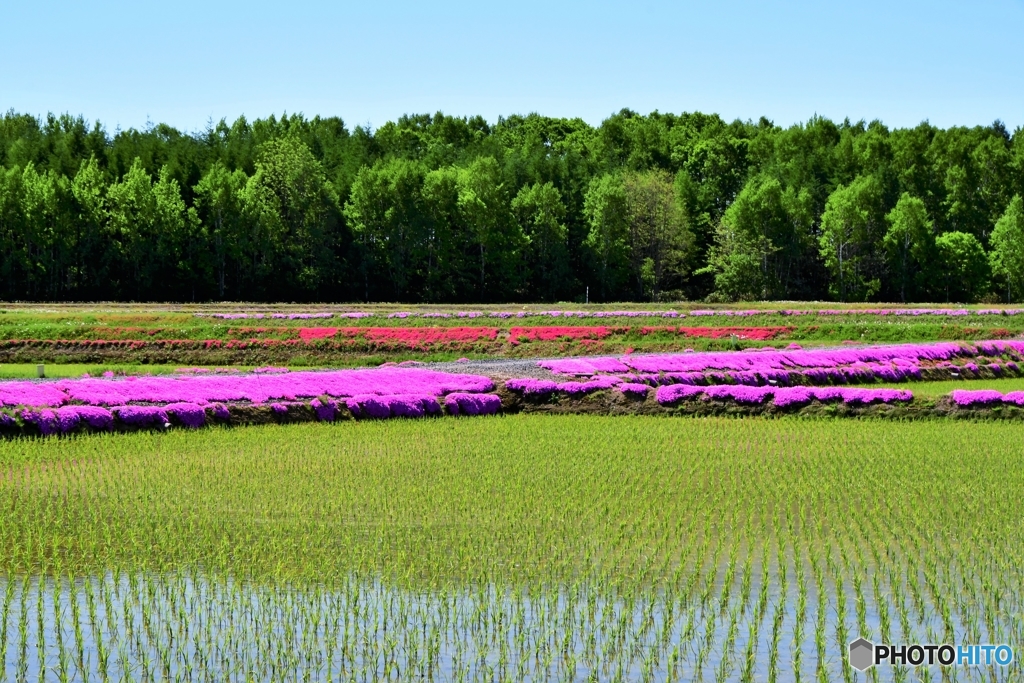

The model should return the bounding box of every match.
[0,110,1024,303]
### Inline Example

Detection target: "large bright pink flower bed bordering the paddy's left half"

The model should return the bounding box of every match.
[0,367,501,435]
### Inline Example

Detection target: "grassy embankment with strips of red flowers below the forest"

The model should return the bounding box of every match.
[0,304,1024,368]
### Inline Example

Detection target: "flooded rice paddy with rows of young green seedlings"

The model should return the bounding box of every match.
[0,413,1024,681]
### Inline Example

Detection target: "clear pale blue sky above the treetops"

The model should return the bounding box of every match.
[0,0,1024,131]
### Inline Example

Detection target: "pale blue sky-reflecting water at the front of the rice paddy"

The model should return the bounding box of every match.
[0,568,1021,681]
